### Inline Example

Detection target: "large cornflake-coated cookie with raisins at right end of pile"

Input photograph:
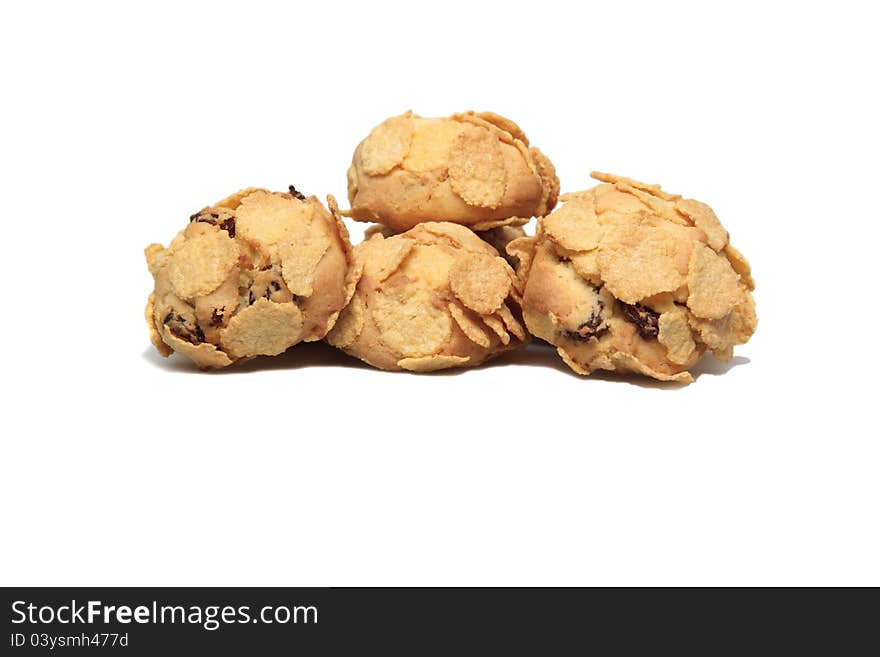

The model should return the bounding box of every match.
[508,172,757,383]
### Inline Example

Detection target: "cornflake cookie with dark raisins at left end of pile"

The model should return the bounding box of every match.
[145,187,355,369]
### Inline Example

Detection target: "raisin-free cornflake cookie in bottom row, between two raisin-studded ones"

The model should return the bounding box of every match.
[327,222,528,372]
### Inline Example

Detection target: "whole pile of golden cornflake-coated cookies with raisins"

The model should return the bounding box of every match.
[146,112,757,382]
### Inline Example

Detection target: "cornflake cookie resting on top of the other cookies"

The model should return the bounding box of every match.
[348,112,559,231]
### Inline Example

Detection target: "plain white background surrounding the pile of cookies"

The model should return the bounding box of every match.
[0,1,880,585]
